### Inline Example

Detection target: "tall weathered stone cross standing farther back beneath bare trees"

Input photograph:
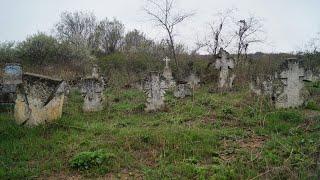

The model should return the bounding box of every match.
[215,48,235,90]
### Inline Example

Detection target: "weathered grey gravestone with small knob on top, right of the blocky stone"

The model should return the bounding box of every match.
[81,68,105,112]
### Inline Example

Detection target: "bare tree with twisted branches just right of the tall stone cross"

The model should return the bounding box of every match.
[236,16,263,61]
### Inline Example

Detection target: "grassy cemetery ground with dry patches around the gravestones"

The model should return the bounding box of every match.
[0,85,320,179]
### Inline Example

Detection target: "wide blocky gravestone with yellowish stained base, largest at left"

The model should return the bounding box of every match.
[14,73,66,126]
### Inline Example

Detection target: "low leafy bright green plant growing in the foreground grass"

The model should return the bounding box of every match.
[69,150,115,170]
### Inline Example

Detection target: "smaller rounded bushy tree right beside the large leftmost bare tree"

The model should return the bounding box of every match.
[97,18,124,54]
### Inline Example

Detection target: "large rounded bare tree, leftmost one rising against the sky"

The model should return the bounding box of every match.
[56,11,96,48]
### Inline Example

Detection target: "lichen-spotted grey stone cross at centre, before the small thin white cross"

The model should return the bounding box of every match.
[144,72,167,112]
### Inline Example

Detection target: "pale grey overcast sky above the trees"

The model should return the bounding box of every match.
[0,0,320,52]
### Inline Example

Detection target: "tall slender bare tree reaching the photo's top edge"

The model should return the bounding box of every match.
[144,0,194,76]
